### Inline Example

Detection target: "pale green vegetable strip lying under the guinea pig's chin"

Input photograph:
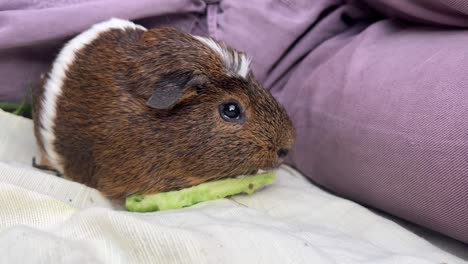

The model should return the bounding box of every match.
[125,172,276,212]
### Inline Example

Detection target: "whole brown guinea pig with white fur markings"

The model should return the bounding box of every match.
[33,19,295,198]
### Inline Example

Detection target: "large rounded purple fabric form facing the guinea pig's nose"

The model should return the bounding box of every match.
[275,20,468,242]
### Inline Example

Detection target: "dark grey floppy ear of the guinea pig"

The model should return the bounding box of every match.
[146,72,204,110]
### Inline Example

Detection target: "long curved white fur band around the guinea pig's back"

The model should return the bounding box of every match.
[39,18,146,172]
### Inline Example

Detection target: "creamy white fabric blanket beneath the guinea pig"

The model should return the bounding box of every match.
[0,111,466,264]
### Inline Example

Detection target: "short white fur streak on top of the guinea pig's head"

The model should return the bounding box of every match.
[194,36,250,78]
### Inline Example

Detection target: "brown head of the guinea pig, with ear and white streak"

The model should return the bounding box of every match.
[128,28,295,184]
